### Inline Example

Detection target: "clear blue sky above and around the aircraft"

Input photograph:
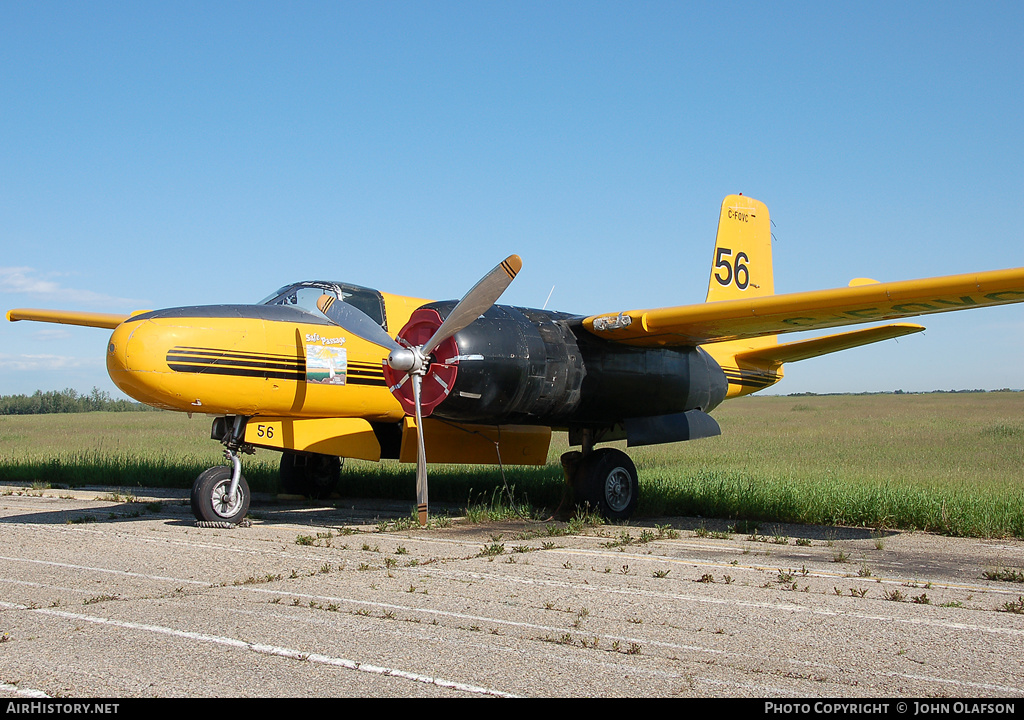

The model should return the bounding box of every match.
[0,0,1024,396]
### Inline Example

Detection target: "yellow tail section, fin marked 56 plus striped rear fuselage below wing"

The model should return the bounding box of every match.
[703,195,782,397]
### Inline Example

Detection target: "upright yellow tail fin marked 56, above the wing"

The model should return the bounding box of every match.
[708,195,775,302]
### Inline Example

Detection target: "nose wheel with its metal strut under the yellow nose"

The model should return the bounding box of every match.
[191,416,255,524]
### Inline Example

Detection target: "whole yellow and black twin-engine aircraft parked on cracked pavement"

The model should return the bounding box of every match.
[7,196,1024,524]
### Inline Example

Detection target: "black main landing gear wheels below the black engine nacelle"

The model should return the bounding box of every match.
[561,429,640,520]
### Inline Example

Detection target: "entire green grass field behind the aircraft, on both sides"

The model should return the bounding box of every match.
[0,392,1024,537]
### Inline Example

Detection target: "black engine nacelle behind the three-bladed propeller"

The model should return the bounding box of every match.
[428,302,728,426]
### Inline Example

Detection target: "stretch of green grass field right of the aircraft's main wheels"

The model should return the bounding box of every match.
[634,392,1024,537]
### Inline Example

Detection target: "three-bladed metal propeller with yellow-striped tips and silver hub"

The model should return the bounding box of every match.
[316,255,522,525]
